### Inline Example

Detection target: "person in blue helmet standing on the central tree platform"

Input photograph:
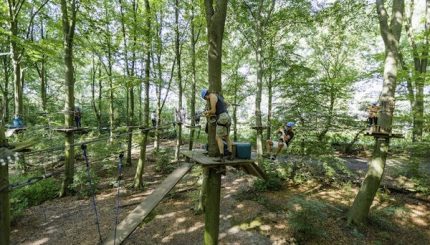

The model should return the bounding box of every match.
[201,89,234,162]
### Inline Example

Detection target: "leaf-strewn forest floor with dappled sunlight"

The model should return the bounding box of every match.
[6,142,430,245]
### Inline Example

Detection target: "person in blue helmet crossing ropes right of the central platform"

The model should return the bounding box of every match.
[266,122,295,160]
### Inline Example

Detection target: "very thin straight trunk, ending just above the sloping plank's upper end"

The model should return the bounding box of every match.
[175,0,185,161]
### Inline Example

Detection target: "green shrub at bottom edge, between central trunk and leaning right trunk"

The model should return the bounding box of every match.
[287,197,327,242]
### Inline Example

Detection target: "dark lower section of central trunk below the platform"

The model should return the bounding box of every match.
[203,168,221,245]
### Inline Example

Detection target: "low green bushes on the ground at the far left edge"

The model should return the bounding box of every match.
[10,175,60,222]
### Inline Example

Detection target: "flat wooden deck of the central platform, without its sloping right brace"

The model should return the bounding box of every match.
[181,149,255,166]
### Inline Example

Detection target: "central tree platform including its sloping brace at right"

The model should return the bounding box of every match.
[181,149,267,179]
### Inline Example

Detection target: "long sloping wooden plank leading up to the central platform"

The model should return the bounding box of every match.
[104,163,193,245]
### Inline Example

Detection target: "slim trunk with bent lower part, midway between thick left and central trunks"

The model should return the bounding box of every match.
[133,0,152,189]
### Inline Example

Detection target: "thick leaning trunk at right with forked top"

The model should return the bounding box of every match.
[348,0,404,224]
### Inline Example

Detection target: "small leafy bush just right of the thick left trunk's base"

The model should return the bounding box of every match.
[72,166,99,197]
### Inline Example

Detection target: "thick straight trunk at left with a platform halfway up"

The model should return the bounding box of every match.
[60,0,78,196]
